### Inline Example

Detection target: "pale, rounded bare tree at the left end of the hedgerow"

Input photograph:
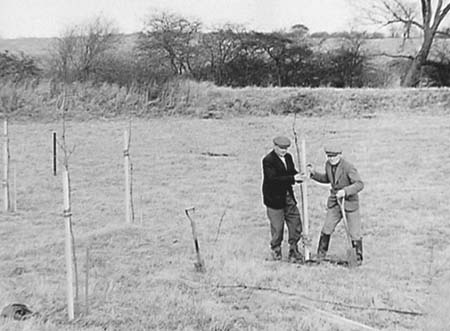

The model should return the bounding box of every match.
[52,17,117,81]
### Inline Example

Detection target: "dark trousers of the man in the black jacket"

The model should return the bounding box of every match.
[267,194,302,249]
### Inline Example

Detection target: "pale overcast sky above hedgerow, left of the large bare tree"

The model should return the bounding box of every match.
[0,0,355,38]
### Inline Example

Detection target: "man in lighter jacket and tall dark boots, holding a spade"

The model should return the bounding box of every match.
[308,146,364,264]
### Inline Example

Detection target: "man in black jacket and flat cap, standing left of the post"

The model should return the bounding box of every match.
[262,136,305,263]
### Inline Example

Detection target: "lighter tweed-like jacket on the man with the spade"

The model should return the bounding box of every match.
[311,158,364,211]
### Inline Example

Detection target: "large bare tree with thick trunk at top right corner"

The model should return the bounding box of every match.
[356,0,450,87]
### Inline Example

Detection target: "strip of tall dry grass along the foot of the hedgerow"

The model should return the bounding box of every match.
[0,79,450,123]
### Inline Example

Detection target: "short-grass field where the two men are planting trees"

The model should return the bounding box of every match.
[0,112,450,331]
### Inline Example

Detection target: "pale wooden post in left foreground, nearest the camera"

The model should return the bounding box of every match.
[62,167,74,321]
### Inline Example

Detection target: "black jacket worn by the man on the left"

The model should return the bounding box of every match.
[262,150,297,209]
